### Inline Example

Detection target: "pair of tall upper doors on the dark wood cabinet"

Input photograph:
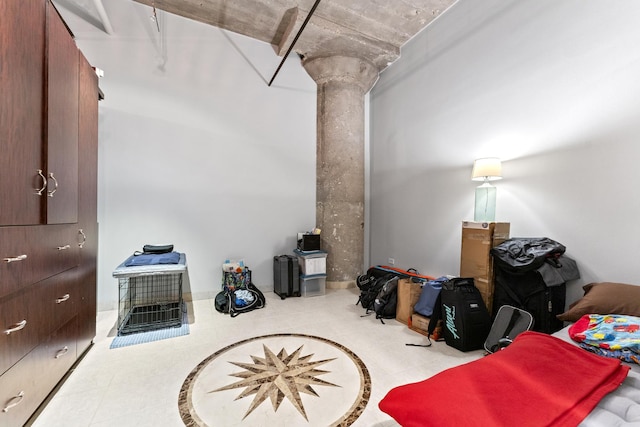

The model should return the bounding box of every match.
[0,0,80,225]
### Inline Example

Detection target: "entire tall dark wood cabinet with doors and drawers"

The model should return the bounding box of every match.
[0,0,99,427]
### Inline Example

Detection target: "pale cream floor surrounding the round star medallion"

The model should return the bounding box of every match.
[28,289,482,427]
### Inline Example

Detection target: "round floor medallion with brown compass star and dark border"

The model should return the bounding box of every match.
[178,334,371,427]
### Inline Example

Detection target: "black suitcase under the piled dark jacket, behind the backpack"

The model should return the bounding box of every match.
[493,265,567,334]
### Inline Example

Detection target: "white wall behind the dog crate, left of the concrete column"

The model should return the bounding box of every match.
[60,0,316,310]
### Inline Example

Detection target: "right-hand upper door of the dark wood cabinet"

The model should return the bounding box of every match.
[45,2,80,224]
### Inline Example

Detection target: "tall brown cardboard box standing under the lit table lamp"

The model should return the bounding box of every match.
[460,221,510,313]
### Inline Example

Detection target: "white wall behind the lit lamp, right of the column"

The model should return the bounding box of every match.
[369,0,640,308]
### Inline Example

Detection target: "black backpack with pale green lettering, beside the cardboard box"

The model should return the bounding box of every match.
[440,278,491,351]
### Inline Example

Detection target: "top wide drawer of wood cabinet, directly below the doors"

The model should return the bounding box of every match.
[0,225,80,298]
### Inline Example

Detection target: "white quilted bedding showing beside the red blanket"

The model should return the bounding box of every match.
[553,327,640,427]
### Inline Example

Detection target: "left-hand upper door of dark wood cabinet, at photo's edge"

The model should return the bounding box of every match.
[0,0,47,225]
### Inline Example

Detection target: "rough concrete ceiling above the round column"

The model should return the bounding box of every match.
[132,0,457,71]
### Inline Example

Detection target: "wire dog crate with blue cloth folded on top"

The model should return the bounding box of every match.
[113,254,186,335]
